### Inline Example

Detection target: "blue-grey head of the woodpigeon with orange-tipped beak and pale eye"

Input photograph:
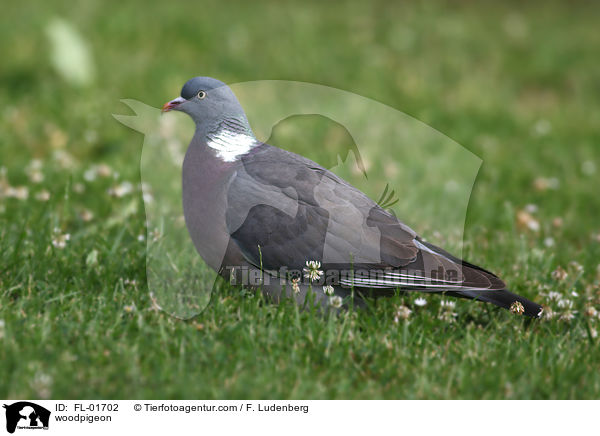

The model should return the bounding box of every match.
[162,77,248,128]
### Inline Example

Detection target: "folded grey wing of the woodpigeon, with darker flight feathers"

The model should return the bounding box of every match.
[226,144,504,290]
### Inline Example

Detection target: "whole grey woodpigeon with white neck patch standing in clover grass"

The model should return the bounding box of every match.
[162,77,542,317]
